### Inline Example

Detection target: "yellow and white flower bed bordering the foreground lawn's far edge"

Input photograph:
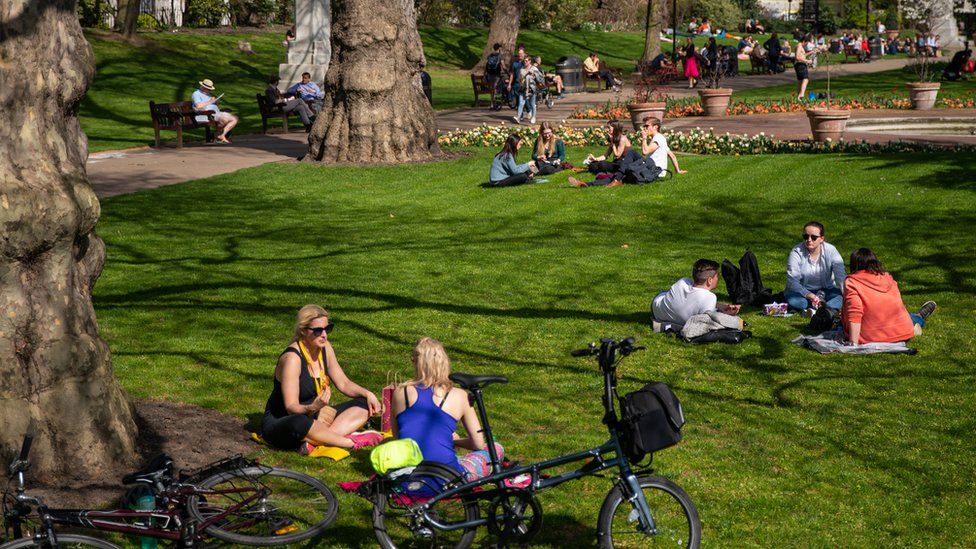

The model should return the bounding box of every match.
[438,125,976,156]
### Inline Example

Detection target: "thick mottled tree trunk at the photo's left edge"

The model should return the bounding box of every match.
[0,0,136,480]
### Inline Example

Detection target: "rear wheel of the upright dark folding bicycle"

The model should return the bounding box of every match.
[373,471,479,549]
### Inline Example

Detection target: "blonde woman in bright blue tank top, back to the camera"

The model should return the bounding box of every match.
[391,337,504,481]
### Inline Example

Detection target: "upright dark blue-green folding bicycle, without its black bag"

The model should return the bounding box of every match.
[358,338,701,549]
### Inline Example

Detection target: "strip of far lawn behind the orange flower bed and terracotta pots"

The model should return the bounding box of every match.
[730,65,976,100]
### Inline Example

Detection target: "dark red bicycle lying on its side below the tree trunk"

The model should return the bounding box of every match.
[0,435,338,549]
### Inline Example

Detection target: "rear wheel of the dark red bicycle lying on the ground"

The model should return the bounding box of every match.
[187,467,339,546]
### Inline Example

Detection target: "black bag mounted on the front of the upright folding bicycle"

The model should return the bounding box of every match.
[620,381,685,463]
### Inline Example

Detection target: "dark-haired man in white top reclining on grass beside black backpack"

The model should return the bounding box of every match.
[651,259,739,324]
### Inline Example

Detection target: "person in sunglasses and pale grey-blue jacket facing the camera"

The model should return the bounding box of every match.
[784,221,847,316]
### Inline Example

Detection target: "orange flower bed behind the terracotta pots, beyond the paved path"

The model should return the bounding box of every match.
[569,95,976,120]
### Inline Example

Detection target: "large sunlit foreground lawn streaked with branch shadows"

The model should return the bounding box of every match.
[94,150,976,547]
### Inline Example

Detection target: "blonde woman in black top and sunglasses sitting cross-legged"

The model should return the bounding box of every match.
[261,305,383,454]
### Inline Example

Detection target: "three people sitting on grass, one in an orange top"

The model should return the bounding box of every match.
[651,221,936,345]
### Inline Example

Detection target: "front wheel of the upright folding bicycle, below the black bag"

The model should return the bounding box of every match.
[597,476,701,549]
